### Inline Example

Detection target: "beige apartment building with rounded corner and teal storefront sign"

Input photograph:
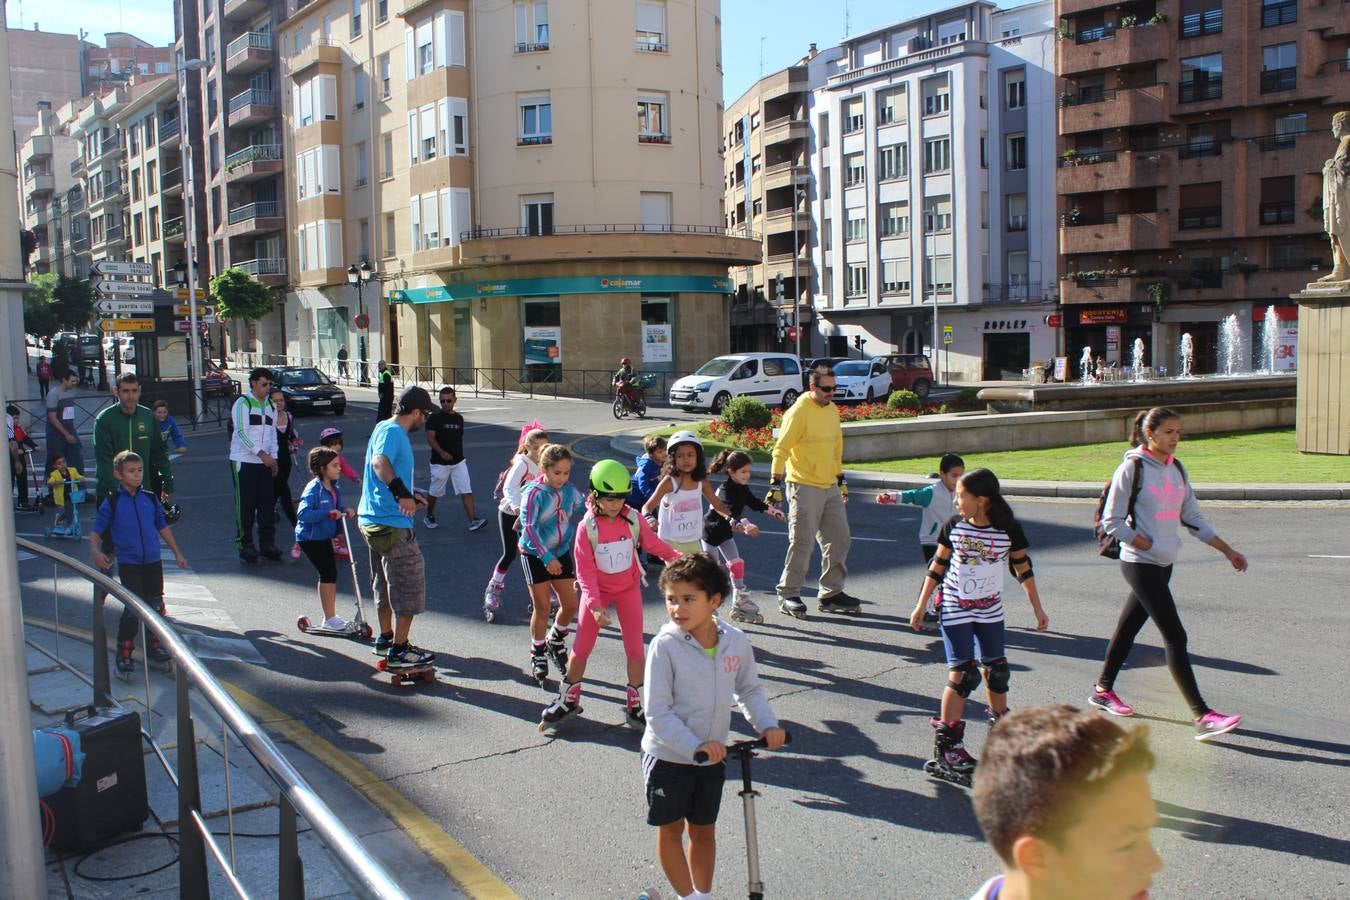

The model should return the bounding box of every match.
[278,0,760,381]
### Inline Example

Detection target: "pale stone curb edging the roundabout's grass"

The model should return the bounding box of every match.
[596,429,1350,501]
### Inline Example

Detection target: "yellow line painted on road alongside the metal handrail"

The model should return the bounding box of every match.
[23,615,517,900]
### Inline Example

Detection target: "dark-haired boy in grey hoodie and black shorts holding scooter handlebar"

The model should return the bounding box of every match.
[643,553,787,899]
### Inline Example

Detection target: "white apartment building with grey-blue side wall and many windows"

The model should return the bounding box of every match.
[809,3,1056,381]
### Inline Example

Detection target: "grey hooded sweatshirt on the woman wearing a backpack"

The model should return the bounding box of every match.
[1102,447,1215,565]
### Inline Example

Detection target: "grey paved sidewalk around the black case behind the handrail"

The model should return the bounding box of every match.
[24,622,464,900]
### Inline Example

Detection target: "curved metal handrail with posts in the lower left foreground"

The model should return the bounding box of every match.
[15,537,409,900]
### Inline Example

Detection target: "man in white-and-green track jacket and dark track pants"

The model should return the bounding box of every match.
[230,368,281,563]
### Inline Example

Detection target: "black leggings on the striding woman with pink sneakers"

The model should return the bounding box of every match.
[1098,561,1210,716]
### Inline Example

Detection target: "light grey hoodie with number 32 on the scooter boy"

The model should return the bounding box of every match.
[643,618,778,765]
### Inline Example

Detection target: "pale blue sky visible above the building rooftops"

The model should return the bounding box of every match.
[5,0,957,103]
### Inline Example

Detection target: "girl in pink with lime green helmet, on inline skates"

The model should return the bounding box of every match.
[539,459,679,734]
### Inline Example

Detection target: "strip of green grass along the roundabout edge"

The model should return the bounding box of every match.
[845,428,1350,484]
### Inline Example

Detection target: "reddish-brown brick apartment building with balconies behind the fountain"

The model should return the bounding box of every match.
[1056,0,1350,372]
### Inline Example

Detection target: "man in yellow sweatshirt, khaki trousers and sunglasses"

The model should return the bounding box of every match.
[770,366,859,619]
